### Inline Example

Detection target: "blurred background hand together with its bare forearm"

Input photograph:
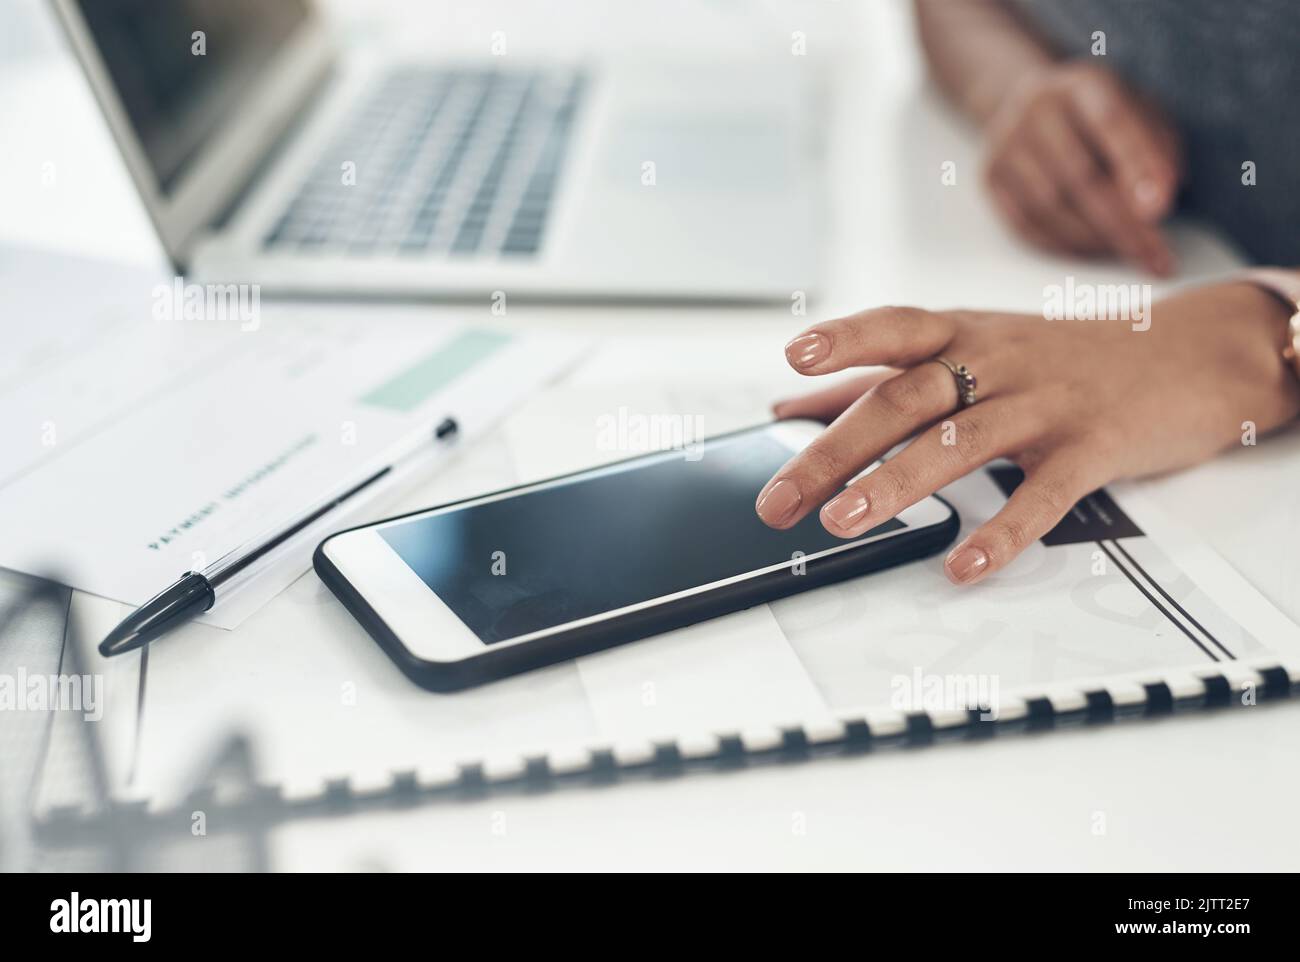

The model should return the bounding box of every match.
[917,0,1183,276]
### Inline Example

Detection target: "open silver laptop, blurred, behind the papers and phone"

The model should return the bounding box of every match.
[52,0,818,302]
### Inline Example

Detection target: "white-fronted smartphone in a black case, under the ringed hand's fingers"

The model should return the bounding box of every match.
[315,421,958,690]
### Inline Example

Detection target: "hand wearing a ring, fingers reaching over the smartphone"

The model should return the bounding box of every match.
[757,283,1300,584]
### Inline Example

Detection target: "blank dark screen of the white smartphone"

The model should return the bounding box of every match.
[380,432,904,645]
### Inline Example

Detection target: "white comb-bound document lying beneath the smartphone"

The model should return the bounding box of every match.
[25,449,1300,852]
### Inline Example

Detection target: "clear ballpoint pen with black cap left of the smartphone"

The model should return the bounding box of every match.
[99,417,460,658]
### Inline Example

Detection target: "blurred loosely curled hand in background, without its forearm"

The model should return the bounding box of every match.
[984,62,1183,276]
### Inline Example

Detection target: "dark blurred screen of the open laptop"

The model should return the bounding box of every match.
[77,0,311,194]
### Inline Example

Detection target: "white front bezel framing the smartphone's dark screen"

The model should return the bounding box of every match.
[321,421,950,663]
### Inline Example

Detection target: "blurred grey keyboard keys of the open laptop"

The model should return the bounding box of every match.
[264,66,585,257]
